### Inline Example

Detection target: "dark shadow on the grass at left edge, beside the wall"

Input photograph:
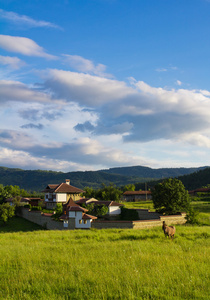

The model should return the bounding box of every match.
[0,217,43,233]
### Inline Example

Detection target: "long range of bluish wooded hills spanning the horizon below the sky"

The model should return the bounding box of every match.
[0,166,210,191]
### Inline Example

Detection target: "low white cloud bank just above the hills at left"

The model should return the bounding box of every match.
[0,130,147,169]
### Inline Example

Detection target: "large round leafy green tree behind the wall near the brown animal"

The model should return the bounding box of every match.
[152,178,190,214]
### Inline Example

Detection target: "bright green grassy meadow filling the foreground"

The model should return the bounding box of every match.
[0,219,210,300]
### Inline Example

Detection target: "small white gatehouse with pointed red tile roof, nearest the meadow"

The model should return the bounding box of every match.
[60,198,97,229]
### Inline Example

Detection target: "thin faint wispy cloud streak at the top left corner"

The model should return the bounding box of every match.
[0,9,62,29]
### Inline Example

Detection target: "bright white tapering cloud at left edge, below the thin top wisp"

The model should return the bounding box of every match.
[0,34,57,59]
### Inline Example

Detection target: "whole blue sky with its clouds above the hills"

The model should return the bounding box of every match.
[0,0,210,172]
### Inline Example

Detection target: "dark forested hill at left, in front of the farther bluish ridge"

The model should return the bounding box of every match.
[0,167,144,191]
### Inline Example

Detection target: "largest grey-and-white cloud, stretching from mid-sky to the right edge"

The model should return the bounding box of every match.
[40,69,210,146]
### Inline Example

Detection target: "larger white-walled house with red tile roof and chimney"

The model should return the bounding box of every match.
[42,179,84,209]
